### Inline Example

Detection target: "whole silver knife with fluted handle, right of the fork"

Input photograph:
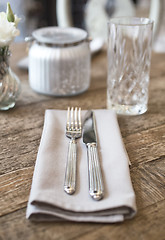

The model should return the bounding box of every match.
[83,111,104,200]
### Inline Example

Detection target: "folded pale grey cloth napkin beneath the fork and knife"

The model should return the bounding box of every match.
[26,110,136,223]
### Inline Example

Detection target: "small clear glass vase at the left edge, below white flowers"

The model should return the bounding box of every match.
[0,46,20,110]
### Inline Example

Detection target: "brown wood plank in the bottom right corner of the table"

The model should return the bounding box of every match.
[75,201,165,240]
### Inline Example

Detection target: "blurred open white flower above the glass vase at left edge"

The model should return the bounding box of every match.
[0,12,20,47]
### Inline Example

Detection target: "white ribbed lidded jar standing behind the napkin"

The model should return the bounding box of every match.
[29,27,91,96]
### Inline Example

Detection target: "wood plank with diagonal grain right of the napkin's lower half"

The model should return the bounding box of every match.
[130,156,165,210]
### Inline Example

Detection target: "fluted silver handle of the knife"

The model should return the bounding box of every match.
[87,143,104,200]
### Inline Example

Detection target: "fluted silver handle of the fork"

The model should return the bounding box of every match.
[64,139,77,194]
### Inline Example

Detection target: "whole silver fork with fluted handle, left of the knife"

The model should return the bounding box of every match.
[64,107,82,194]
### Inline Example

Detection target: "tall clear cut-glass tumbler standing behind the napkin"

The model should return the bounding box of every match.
[107,17,153,115]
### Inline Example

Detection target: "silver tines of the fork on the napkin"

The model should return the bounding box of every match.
[66,107,81,131]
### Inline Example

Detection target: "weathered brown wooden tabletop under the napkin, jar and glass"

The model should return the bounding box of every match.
[0,44,165,240]
